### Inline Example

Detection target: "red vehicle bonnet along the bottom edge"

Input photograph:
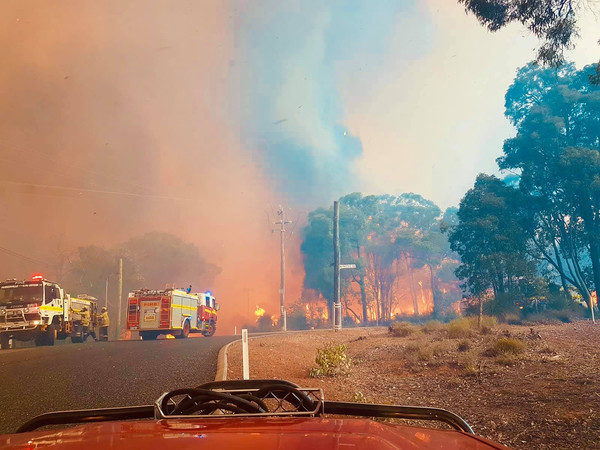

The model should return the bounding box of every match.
[0,417,506,450]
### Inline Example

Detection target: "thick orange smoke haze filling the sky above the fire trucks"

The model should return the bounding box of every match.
[0,0,303,334]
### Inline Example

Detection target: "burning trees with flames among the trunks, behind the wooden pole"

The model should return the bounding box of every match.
[301,193,460,322]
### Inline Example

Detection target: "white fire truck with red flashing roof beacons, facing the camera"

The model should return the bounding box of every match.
[0,275,97,349]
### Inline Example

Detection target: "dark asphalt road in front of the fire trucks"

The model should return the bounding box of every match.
[0,336,239,433]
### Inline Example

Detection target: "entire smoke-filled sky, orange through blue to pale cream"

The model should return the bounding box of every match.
[0,0,600,330]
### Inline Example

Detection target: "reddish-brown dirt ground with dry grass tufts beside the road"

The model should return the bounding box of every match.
[228,321,600,449]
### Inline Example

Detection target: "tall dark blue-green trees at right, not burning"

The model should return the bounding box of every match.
[448,63,600,312]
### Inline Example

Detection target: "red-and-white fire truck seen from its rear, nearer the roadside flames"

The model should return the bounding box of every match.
[127,289,220,340]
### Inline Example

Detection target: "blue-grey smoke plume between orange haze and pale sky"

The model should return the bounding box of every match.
[235,0,408,204]
